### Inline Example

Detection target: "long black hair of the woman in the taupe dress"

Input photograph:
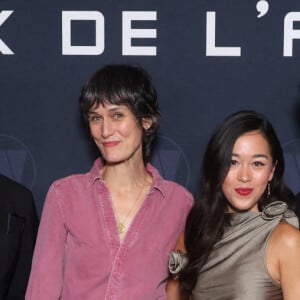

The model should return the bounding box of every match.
[178,110,293,294]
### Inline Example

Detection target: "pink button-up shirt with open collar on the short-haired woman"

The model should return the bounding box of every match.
[26,159,192,300]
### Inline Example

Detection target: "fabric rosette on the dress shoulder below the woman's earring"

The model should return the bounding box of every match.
[261,201,299,228]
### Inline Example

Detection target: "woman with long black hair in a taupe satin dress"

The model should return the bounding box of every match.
[168,111,300,300]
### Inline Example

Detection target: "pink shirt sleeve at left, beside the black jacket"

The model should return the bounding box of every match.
[25,185,66,300]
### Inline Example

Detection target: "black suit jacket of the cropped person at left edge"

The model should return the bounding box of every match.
[0,175,39,300]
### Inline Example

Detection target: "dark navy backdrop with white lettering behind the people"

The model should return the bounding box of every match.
[0,0,300,211]
